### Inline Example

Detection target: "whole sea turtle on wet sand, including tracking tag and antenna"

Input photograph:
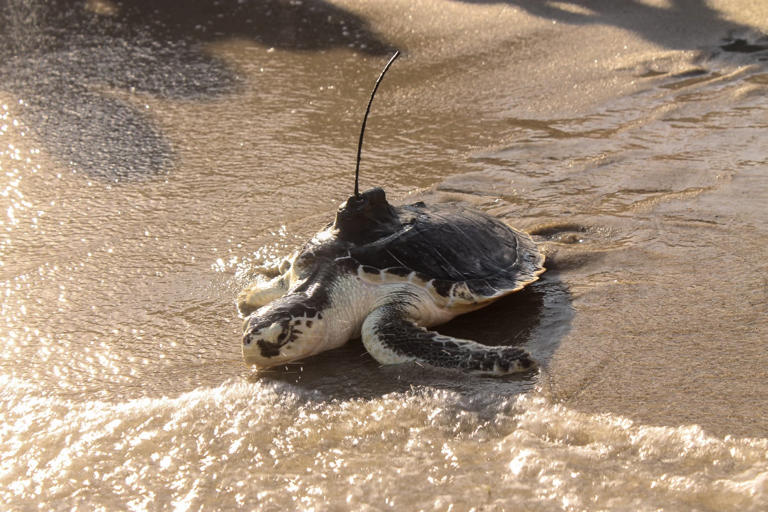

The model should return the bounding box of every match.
[237,53,544,375]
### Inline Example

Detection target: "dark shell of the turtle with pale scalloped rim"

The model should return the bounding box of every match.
[337,198,544,306]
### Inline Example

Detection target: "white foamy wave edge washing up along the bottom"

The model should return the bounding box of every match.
[0,378,768,511]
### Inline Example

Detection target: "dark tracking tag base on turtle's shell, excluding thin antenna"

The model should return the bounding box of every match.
[333,187,401,244]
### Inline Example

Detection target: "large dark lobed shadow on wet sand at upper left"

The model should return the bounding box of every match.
[0,0,387,180]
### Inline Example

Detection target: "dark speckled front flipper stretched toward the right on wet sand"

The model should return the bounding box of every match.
[362,304,536,375]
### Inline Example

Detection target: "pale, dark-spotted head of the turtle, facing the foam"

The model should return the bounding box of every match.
[243,295,326,368]
